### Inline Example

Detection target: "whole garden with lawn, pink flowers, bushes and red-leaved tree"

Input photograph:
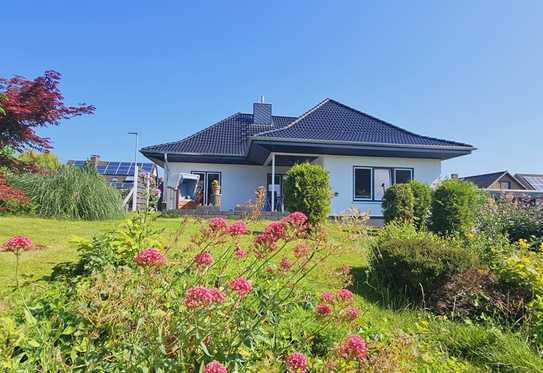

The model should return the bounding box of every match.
[0,73,543,373]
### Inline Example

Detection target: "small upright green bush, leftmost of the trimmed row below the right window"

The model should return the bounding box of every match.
[383,184,415,224]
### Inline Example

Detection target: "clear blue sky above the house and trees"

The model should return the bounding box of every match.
[0,0,543,175]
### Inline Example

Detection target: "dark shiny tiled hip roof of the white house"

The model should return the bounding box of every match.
[141,99,475,164]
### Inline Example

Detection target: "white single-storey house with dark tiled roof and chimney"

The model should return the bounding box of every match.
[141,99,475,217]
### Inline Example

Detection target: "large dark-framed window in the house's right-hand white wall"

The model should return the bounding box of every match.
[353,166,413,201]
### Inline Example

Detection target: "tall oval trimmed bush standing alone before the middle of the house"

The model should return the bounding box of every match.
[284,163,331,224]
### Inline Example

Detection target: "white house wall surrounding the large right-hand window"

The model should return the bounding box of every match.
[321,155,441,216]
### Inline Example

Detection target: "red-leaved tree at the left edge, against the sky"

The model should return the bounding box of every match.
[0,70,95,165]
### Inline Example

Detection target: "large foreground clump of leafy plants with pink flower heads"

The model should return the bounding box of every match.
[0,213,376,373]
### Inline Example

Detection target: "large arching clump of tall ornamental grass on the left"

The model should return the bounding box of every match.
[10,165,124,220]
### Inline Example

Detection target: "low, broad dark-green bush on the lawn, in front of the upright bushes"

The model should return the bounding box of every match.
[370,223,479,301]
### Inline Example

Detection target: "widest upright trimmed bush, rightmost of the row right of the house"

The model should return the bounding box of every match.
[432,179,485,236]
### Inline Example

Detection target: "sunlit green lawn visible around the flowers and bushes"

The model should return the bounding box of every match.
[0,217,543,372]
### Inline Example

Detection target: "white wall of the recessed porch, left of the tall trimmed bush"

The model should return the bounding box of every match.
[164,162,287,210]
